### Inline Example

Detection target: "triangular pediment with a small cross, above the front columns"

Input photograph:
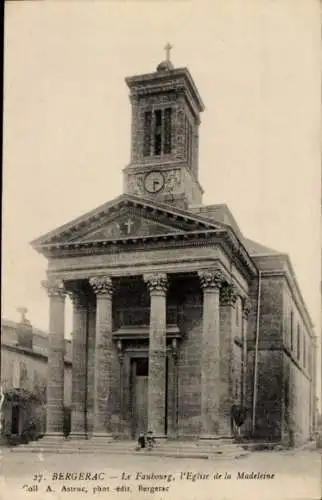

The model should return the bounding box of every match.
[32,195,224,251]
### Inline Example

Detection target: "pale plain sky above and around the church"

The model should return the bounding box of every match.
[2,0,321,356]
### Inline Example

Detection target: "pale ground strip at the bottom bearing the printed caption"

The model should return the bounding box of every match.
[0,449,322,500]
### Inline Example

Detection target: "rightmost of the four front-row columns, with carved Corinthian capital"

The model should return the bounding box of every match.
[198,269,223,439]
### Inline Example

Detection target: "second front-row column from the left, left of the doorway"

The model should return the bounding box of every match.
[90,276,113,439]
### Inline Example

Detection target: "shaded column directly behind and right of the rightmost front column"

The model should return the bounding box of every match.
[220,283,237,437]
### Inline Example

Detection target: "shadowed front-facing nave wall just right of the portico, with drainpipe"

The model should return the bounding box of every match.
[246,276,283,440]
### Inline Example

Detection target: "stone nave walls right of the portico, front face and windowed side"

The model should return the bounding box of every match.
[247,274,313,444]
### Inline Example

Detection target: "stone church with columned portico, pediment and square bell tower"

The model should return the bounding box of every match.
[33,55,316,442]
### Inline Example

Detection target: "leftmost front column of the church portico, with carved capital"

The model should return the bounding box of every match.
[42,279,66,437]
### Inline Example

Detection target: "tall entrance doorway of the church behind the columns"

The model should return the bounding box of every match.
[131,357,149,437]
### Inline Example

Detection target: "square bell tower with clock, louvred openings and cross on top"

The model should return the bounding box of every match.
[124,44,204,209]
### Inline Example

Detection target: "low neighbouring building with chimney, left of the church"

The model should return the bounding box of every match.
[1,313,71,441]
